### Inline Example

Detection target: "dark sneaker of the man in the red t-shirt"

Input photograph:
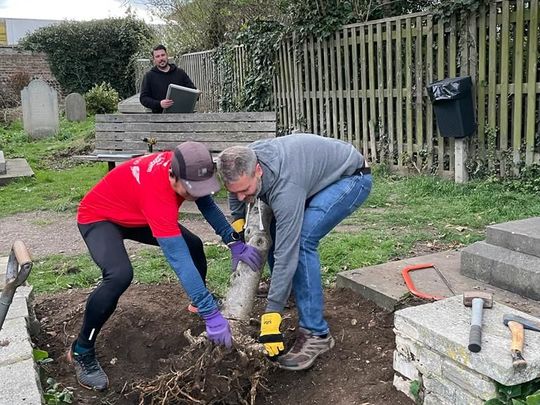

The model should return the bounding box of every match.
[67,342,109,391]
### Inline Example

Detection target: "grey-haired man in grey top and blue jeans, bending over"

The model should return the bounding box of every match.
[217,134,372,370]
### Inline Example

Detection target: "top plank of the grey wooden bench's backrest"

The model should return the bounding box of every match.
[96,112,276,124]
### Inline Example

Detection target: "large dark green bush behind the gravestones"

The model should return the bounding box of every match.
[21,17,154,98]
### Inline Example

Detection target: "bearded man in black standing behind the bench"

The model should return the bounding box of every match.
[139,45,196,113]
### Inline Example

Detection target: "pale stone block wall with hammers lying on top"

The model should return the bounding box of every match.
[394,295,540,405]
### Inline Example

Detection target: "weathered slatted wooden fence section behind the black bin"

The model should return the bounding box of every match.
[182,0,540,176]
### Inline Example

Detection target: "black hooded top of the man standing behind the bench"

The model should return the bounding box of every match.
[139,63,196,113]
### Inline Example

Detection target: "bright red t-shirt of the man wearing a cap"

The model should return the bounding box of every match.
[77,152,184,238]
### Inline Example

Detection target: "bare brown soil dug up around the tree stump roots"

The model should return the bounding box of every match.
[35,284,412,405]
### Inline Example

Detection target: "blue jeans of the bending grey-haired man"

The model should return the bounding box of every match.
[282,174,373,335]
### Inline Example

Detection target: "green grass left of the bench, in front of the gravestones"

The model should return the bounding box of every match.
[0,118,107,217]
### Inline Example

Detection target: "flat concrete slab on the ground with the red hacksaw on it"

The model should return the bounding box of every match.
[337,251,540,317]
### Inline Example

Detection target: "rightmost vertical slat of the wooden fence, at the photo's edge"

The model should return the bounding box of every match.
[525,0,538,165]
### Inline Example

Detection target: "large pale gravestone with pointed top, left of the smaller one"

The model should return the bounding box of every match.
[21,79,59,139]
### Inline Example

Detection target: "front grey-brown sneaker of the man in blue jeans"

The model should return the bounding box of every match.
[277,328,336,371]
